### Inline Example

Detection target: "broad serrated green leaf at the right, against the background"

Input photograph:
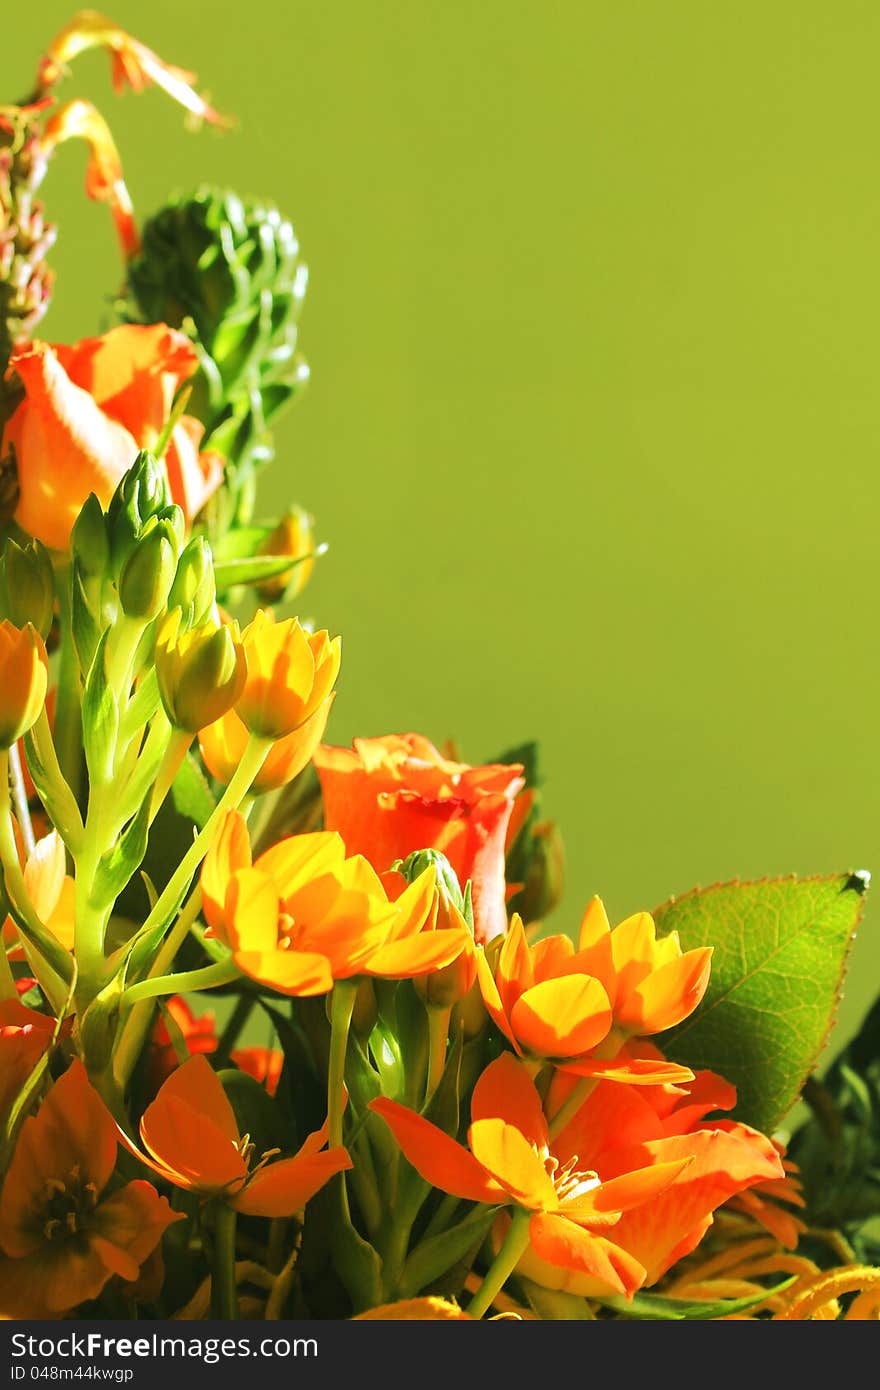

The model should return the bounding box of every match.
[653,874,867,1133]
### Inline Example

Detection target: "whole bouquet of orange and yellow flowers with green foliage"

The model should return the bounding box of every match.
[0,11,880,1321]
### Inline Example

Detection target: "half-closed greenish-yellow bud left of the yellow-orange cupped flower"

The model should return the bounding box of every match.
[156,609,247,734]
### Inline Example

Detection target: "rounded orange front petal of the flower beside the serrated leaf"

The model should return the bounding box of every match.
[510,974,612,1056]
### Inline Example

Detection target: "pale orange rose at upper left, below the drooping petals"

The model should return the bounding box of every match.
[3,324,222,550]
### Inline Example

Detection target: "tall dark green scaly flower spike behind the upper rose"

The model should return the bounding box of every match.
[124,188,309,537]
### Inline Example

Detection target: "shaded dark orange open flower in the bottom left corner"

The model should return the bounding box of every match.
[0,1062,179,1318]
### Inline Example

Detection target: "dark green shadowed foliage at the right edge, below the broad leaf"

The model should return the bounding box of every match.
[790,999,880,1265]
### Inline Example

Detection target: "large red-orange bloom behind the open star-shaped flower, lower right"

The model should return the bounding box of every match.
[519,1045,783,1297]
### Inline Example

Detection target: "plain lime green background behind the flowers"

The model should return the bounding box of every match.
[0,0,880,1041]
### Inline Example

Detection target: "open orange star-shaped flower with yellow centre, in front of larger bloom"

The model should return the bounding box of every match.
[370,1052,692,1294]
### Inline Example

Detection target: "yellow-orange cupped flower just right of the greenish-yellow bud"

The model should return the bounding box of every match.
[235,609,342,738]
